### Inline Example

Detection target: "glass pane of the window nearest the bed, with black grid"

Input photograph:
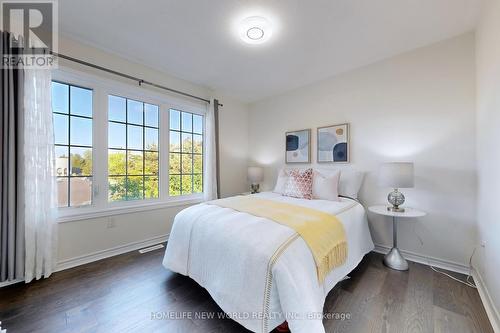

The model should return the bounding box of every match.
[169,109,204,196]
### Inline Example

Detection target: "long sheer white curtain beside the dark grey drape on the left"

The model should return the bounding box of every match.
[24,69,57,282]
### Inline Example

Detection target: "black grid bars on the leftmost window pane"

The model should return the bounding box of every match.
[52,80,94,207]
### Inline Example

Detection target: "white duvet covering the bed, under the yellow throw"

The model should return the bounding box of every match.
[163,192,374,333]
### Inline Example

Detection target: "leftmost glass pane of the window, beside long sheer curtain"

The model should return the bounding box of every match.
[52,81,92,207]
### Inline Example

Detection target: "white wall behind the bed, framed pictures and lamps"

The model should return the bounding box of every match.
[249,33,476,265]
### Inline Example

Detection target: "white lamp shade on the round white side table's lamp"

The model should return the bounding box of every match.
[379,162,415,188]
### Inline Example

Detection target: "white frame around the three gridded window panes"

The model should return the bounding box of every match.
[52,66,207,223]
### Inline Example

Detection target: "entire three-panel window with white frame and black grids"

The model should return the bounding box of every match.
[51,68,205,221]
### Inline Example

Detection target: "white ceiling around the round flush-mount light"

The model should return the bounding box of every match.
[59,0,481,102]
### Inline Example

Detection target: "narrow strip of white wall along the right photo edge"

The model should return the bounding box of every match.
[475,0,500,320]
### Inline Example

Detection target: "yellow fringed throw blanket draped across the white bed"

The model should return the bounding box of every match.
[207,196,347,283]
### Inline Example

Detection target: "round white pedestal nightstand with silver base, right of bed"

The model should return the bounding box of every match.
[368,205,427,271]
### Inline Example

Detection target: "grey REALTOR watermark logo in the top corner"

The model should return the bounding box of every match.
[0,0,58,69]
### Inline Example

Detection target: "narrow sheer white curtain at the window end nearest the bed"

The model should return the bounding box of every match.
[203,99,217,201]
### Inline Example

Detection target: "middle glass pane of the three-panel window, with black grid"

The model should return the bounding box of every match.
[108,95,159,201]
